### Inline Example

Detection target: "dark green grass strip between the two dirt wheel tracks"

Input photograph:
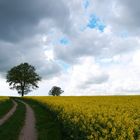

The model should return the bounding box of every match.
[0,99,26,140]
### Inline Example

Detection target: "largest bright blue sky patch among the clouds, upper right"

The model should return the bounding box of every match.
[87,14,106,32]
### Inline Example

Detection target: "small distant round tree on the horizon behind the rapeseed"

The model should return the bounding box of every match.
[49,86,64,96]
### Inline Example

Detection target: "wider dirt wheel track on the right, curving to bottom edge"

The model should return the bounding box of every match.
[19,101,37,140]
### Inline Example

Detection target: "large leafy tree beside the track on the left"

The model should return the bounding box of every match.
[6,63,41,96]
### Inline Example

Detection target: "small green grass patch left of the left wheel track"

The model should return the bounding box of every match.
[0,99,14,118]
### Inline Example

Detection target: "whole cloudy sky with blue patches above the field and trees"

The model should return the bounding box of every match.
[0,0,140,96]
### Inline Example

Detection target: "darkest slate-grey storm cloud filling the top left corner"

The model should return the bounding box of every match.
[0,0,69,41]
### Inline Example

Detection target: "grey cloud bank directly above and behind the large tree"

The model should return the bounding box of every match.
[0,39,61,79]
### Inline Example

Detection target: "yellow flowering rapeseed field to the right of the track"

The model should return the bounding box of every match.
[29,96,140,140]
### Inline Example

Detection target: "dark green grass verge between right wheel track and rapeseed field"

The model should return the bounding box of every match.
[24,99,62,140]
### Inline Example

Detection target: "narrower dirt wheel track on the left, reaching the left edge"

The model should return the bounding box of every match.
[0,100,17,125]
